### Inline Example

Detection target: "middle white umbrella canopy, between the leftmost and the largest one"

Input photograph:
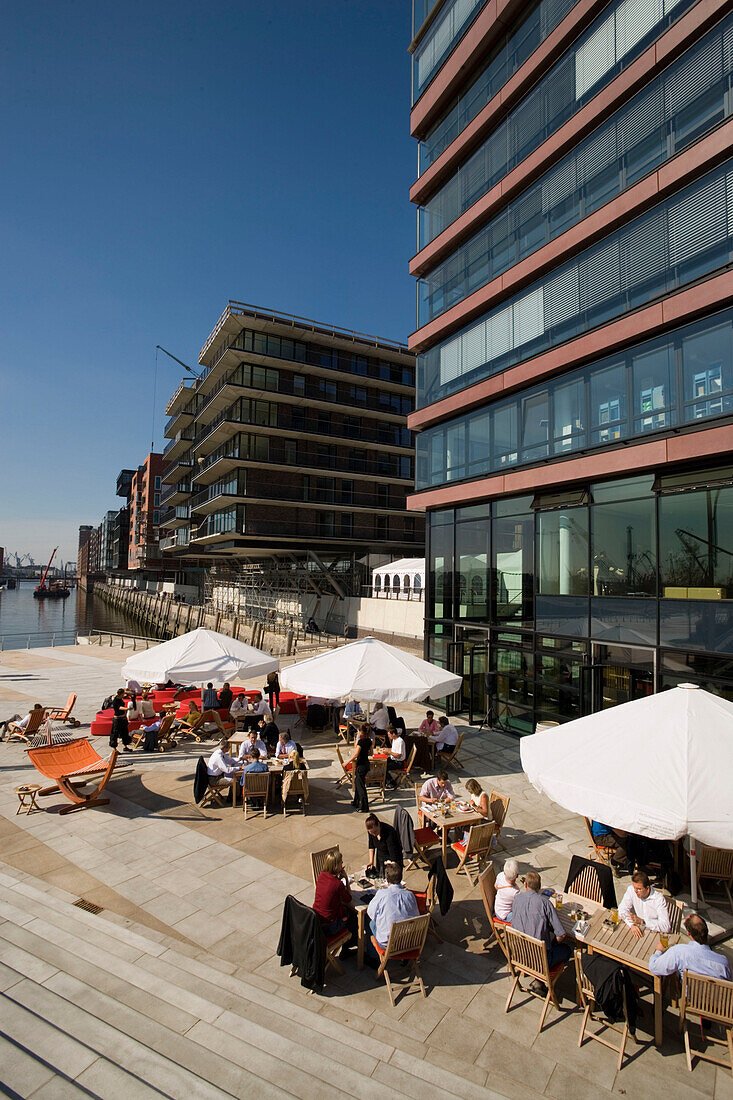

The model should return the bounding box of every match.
[280,638,461,703]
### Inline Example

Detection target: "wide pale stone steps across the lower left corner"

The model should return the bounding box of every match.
[0,862,506,1100]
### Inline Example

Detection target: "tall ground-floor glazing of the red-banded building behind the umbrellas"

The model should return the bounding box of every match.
[426,466,733,733]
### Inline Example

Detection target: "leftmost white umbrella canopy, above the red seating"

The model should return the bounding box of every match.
[122,627,280,684]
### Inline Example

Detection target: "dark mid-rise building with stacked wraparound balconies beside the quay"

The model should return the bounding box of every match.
[161,301,424,580]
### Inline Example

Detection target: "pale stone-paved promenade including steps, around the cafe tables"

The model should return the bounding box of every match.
[0,647,733,1100]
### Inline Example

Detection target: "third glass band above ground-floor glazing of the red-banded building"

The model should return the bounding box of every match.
[417,15,733,326]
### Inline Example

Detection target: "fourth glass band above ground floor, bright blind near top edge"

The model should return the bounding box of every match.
[417,0,693,249]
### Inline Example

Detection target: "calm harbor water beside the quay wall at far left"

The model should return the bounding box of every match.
[0,581,145,649]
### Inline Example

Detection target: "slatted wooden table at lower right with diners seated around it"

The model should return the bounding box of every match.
[558,893,683,1046]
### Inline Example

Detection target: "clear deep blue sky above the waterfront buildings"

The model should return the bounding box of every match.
[0,0,416,560]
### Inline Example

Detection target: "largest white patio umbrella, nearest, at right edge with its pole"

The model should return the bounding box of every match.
[519,684,733,904]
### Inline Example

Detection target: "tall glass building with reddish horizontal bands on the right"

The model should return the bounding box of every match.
[408,0,733,734]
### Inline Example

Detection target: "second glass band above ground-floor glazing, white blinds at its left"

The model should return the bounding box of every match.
[417,161,733,419]
